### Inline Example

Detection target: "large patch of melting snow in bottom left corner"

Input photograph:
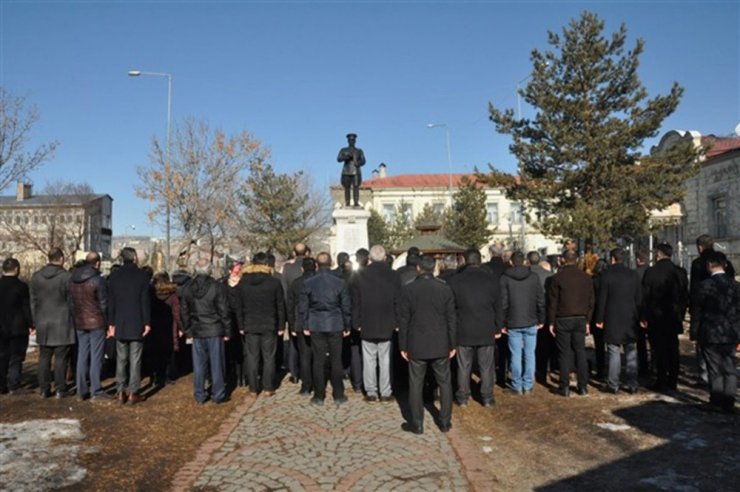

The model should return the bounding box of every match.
[0,419,87,491]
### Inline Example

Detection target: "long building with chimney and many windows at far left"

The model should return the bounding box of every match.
[0,183,113,270]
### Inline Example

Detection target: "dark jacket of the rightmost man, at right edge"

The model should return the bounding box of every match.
[691,273,740,345]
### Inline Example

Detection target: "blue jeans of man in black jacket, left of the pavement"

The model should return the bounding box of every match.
[193,337,226,403]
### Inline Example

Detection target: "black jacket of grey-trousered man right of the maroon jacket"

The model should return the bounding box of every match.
[108,263,151,340]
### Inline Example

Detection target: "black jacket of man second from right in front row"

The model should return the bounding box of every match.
[642,258,688,333]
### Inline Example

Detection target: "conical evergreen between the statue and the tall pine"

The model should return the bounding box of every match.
[444,177,491,248]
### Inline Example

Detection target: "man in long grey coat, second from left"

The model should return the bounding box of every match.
[31,248,75,398]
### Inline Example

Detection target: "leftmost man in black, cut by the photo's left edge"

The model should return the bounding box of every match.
[0,258,33,394]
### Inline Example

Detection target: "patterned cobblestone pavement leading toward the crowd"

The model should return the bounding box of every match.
[181,384,472,491]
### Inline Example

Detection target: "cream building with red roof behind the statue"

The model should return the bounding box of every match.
[332,164,561,256]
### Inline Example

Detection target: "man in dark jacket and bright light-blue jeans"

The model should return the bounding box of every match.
[501,251,545,395]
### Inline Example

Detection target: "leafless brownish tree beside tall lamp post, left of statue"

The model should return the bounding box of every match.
[136,119,269,267]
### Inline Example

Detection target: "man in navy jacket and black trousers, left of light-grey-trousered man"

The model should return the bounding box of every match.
[297,252,352,405]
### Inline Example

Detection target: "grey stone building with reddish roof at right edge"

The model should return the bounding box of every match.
[653,130,740,265]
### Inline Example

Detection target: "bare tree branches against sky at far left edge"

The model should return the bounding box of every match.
[0,87,59,190]
